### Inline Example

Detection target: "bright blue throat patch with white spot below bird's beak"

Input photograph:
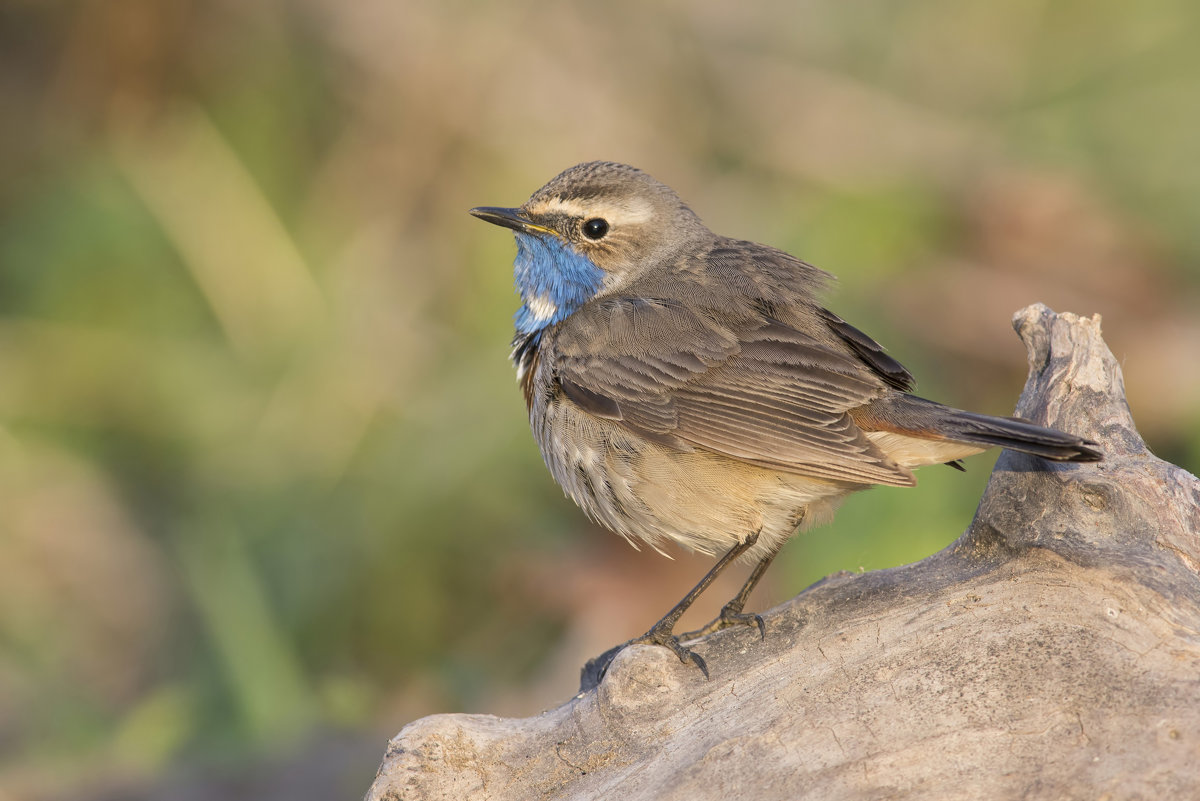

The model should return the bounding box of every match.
[512,233,604,333]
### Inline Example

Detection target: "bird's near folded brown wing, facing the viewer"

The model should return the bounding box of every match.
[552,297,913,486]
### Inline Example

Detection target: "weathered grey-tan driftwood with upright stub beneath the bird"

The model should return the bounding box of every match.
[367,306,1200,801]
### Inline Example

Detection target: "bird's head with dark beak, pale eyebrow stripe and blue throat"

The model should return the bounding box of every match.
[470,162,710,333]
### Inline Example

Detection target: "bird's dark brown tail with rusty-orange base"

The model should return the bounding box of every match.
[860,392,1104,462]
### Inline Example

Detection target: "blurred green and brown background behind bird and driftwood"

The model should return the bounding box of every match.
[0,0,1200,800]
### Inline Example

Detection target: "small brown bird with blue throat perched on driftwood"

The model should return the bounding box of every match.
[470,162,1102,680]
